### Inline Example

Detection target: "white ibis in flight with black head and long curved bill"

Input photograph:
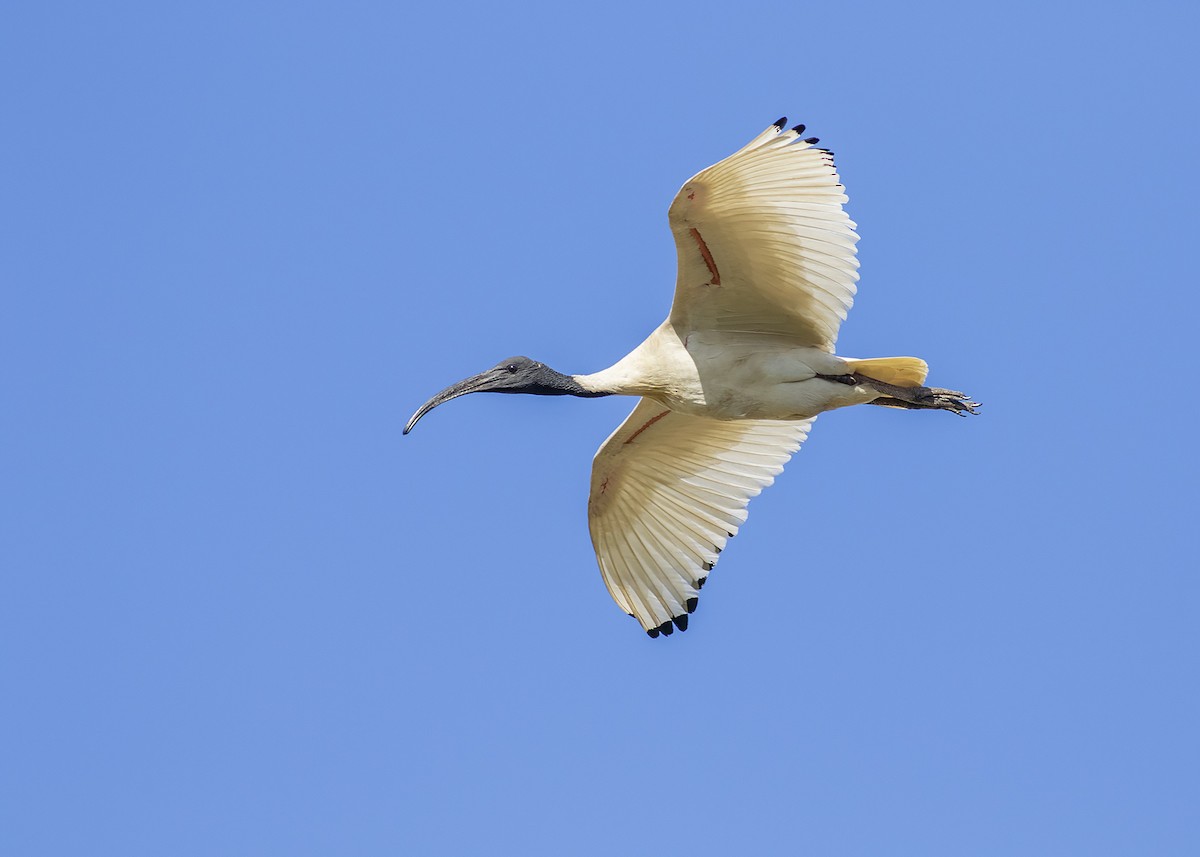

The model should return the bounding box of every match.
[404,119,978,637]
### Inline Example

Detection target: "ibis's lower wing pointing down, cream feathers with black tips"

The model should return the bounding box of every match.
[588,398,816,637]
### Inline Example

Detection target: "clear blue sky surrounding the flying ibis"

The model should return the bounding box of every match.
[0,2,1200,857]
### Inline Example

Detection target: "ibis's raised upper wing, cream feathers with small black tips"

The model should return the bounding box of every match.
[670,119,858,352]
